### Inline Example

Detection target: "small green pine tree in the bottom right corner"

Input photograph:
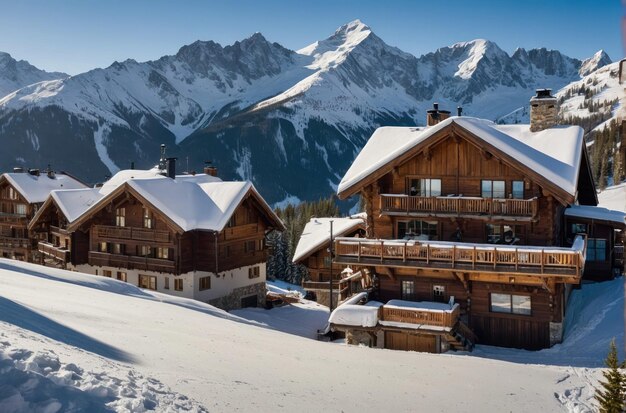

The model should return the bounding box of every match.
[595,339,626,413]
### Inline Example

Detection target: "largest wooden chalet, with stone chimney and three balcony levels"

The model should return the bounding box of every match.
[331,90,625,352]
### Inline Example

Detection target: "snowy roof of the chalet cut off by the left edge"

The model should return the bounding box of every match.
[2,172,86,204]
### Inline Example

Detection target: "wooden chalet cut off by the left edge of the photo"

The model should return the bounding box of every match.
[0,168,85,262]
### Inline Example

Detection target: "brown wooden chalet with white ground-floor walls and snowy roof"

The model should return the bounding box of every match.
[30,164,283,309]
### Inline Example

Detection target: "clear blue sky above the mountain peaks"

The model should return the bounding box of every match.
[0,0,626,74]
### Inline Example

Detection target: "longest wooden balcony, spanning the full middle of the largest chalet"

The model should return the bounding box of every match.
[334,236,586,283]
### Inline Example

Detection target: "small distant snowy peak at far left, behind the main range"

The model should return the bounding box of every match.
[0,52,68,97]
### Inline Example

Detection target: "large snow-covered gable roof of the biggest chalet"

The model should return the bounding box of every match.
[337,116,583,200]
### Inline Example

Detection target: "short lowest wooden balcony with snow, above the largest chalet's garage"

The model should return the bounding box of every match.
[379,300,461,329]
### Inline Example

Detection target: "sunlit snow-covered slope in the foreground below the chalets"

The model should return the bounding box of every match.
[0,259,624,412]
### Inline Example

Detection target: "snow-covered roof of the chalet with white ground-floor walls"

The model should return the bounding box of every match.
[64,174,284,232]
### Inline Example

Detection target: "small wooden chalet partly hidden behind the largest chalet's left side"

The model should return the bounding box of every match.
[292,214,368,306]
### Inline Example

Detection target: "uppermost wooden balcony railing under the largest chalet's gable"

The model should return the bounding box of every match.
[380,194,537,218]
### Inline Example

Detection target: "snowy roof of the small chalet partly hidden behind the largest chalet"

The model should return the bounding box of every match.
[293,213,365,262]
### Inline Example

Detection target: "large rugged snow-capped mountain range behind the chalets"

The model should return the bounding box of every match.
[0,20,608,206]
